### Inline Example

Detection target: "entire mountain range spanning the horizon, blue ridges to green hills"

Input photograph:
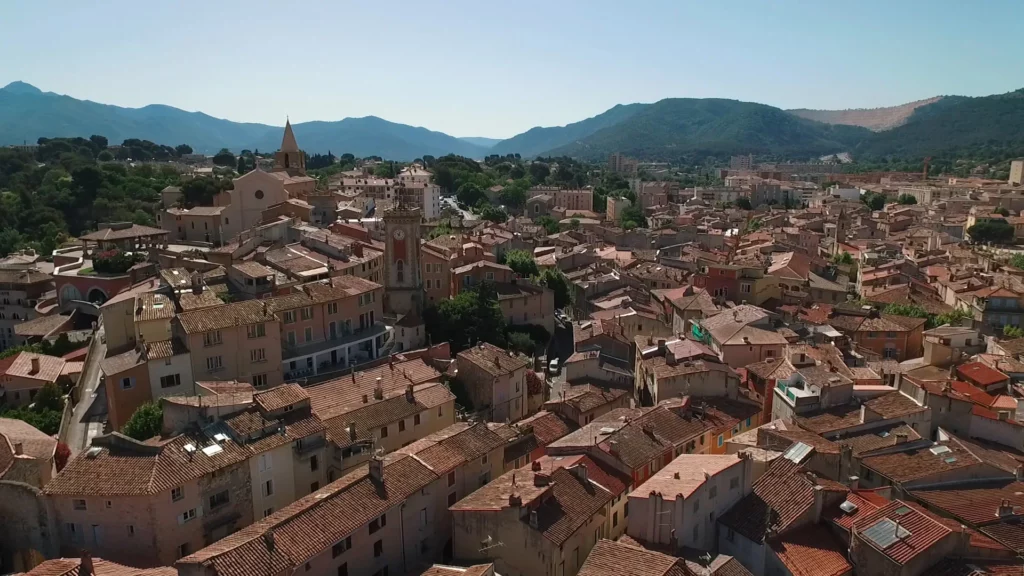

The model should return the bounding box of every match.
[0,82,1024,161]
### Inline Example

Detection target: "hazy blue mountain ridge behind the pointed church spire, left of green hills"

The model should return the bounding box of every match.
[0,82,487,161]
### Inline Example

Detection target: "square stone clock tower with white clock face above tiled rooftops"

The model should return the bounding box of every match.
[381,202,424,316]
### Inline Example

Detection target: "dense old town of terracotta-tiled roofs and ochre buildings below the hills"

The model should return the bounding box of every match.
[6,123,1024,576]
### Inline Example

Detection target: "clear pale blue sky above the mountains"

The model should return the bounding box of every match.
[0,0,1024,137]
